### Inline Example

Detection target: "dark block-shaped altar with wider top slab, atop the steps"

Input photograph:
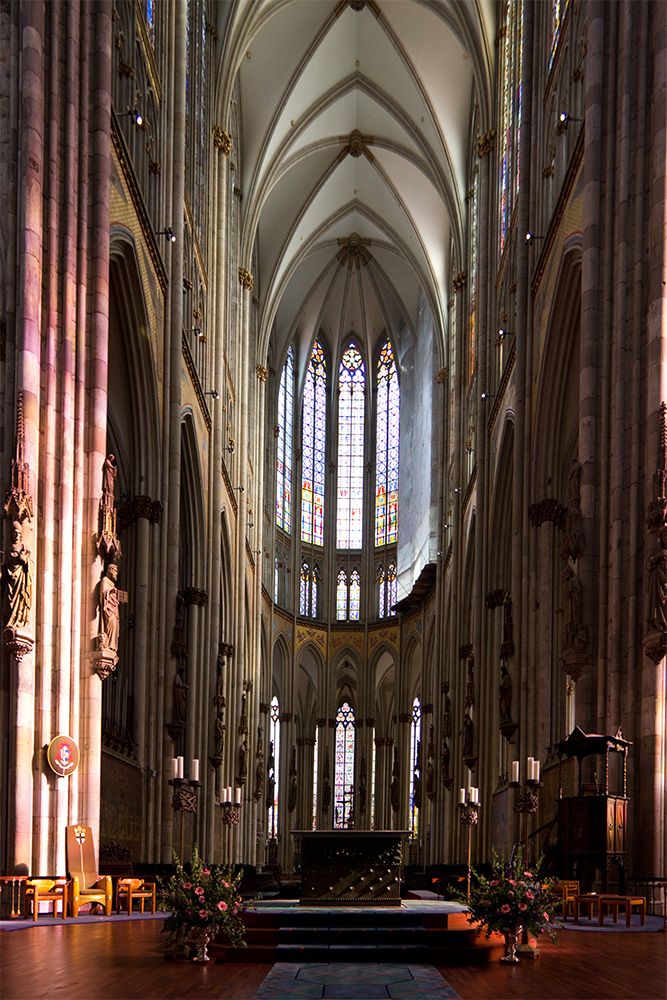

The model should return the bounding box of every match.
[292,830,410,906]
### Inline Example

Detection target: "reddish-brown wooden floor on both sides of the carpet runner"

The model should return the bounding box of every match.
[0,919,667,1000]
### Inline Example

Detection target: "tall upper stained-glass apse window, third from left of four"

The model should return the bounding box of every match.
[336,342,365,549]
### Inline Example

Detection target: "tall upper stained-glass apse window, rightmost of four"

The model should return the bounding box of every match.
[375,341,401,545]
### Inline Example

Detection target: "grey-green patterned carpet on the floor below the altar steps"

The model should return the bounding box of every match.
[252,962,458,1000]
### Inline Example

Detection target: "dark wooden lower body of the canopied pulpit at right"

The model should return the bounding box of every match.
[558,795,628,892]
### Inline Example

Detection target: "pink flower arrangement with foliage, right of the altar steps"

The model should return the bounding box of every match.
[458,848,561,941]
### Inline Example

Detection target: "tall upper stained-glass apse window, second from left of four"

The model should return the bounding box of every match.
[301,341,327,545]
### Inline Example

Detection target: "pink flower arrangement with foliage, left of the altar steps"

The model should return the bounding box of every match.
[157,844,245,947]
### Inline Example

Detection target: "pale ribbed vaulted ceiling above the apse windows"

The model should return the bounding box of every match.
[218,0,495,378]
